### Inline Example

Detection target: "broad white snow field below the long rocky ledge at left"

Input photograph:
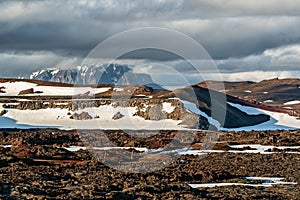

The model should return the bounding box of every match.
[0,104,184,130]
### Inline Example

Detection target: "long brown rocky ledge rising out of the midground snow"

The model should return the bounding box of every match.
[3,98,209,129]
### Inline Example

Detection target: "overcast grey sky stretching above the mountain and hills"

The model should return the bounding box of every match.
[0,0,300,80]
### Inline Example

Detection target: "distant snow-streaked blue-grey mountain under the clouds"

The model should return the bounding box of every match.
[30,64,153,85]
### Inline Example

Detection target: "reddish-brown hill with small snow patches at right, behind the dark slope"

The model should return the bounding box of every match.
[197,79,300,117]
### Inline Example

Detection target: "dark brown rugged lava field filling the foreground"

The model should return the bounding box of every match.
[0,129,300,199]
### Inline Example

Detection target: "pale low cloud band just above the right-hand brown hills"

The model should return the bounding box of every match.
[135,44,300,75]
